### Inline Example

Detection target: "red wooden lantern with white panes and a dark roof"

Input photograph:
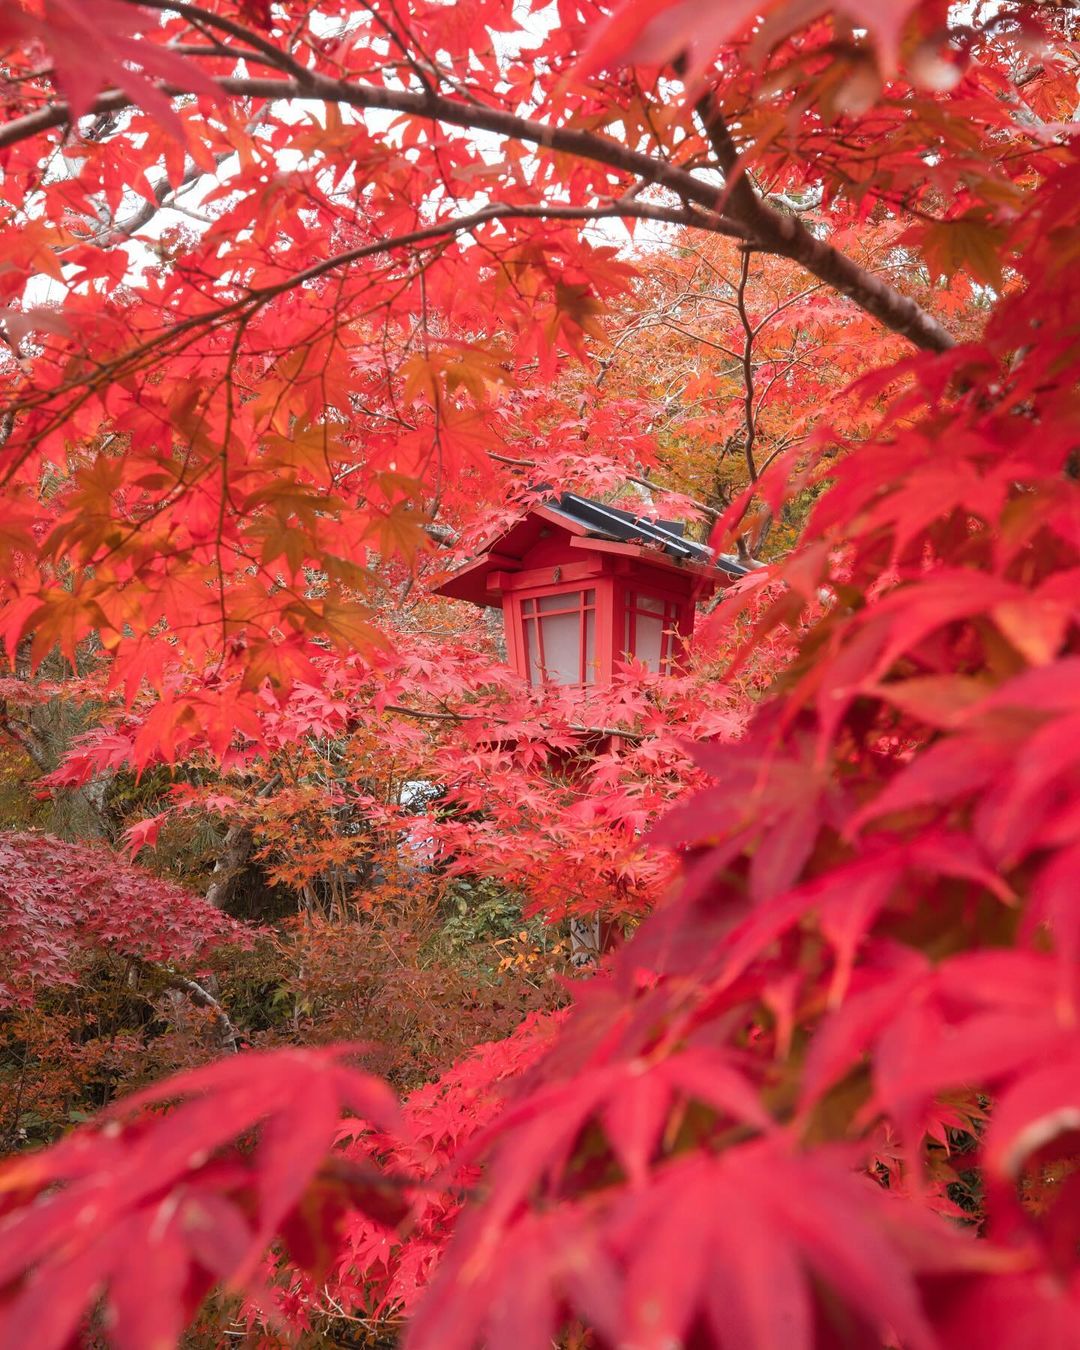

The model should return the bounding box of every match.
[437,493,747,689]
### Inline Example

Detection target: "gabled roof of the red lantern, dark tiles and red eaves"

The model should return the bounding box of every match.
[435,493,749,605]
